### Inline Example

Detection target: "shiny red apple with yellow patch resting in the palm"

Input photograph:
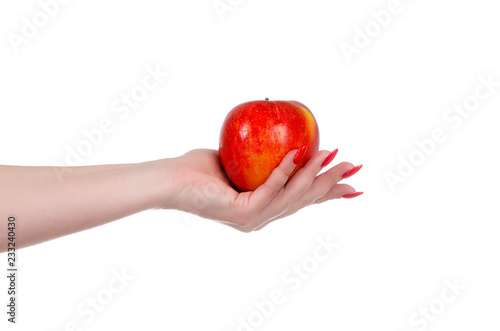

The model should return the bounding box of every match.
[219,99,319,191]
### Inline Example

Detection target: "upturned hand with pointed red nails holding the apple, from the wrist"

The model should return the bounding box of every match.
[165,149,362,232]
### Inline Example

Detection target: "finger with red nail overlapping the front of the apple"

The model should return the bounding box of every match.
[250,149,298,212]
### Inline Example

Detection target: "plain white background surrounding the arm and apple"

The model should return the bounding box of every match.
[0,0,500,331]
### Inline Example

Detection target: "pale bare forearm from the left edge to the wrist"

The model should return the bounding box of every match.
[0,160,171,252]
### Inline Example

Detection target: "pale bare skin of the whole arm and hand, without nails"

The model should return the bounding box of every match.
[0,149,356,252]
